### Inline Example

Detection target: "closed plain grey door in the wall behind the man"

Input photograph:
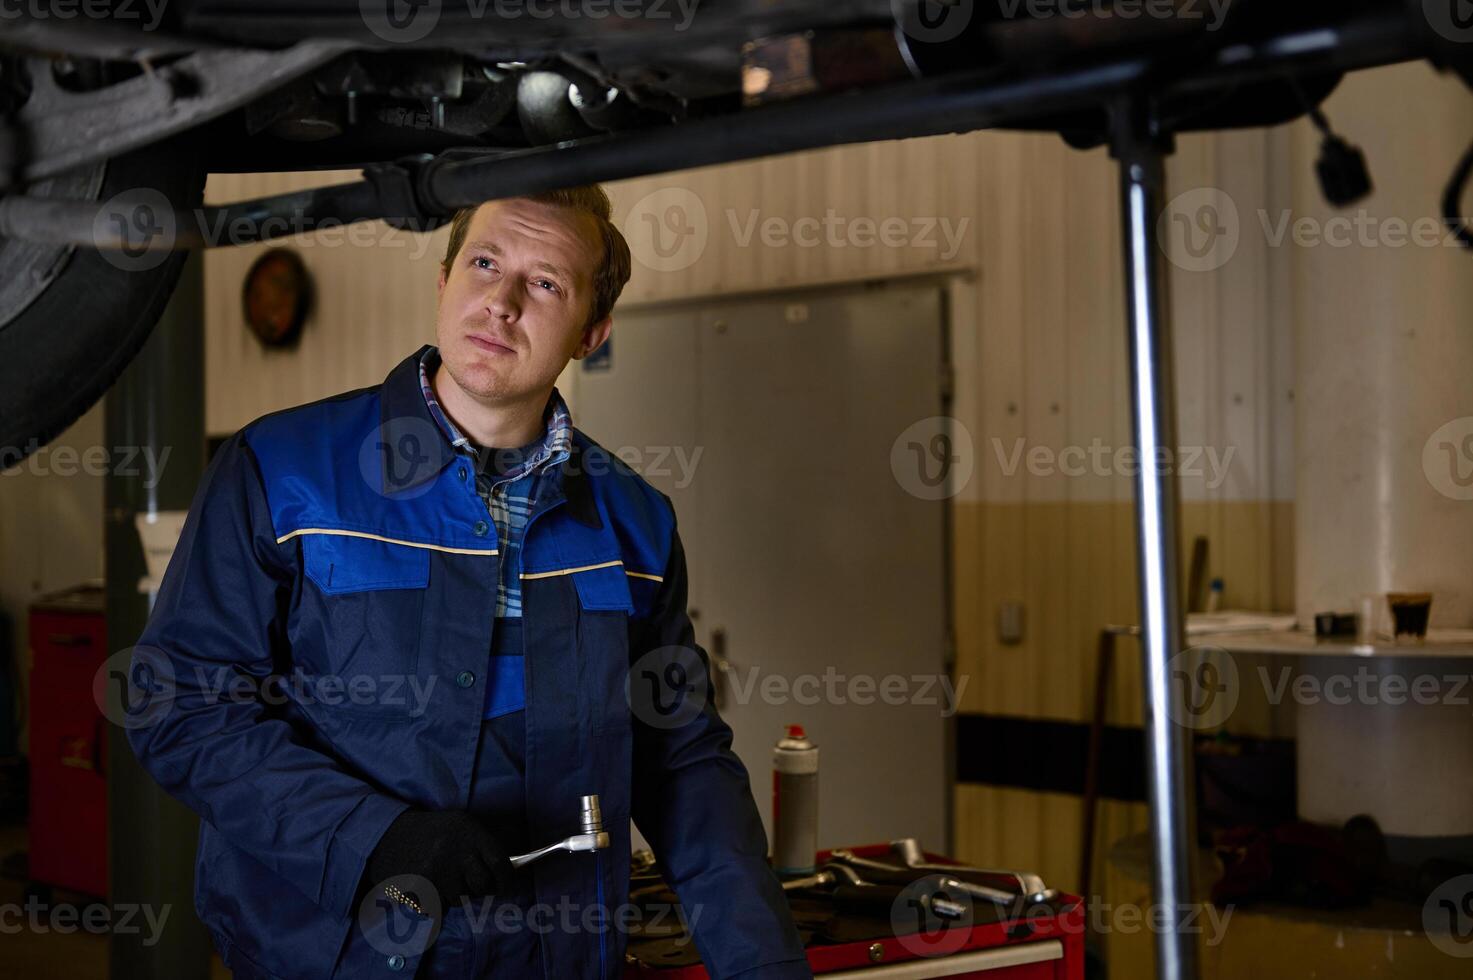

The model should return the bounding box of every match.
[573,281,952,849]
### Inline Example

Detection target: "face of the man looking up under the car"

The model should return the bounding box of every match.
[436,197,613,405]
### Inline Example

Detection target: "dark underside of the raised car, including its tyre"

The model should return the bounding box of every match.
[0,0,1473,489]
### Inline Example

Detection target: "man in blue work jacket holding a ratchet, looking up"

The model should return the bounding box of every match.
[128,186,812,980]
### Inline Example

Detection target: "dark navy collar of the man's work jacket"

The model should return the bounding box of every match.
[377,345,604,531]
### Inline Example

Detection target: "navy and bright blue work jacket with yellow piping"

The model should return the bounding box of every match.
[128,352,810,980]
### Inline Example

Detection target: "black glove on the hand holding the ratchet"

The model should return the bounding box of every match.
[355,809,513,908]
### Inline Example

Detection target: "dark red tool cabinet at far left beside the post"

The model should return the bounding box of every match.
[28,587,108,897]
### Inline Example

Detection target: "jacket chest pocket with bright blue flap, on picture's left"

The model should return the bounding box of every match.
[302,533,430,698]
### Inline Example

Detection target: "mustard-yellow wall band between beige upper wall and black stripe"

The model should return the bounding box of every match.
[953,501,1293,725]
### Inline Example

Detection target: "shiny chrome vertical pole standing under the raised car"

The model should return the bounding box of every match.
[1112,99,1199,980]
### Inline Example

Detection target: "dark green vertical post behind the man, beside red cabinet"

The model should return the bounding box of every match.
[103,252,209,980]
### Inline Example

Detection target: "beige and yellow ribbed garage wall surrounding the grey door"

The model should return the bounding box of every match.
[206,59,1467,887]
